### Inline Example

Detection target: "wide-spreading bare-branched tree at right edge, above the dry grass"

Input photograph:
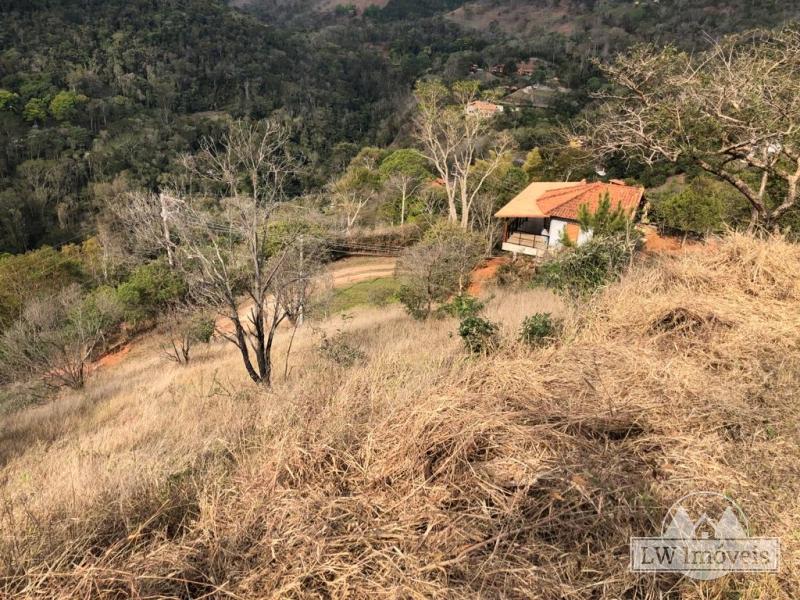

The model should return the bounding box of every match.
[581,26,800,227]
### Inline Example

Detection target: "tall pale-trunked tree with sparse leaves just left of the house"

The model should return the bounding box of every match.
[415,81,512,229]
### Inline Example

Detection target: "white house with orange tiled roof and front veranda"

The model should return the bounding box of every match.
[495,179,644,256]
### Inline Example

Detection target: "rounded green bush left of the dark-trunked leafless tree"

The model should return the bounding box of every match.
[117,261,188,324]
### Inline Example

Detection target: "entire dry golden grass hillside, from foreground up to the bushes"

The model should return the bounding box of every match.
[0,236,800,600]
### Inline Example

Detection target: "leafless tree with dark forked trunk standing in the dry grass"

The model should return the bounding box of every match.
[170,120,318,385]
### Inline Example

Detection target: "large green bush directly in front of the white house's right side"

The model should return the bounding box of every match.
[534,236,636,298]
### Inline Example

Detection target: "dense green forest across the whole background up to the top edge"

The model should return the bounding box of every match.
[0,0,798,253]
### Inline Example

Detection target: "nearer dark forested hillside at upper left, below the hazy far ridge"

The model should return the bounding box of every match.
[0,0,476,252]
